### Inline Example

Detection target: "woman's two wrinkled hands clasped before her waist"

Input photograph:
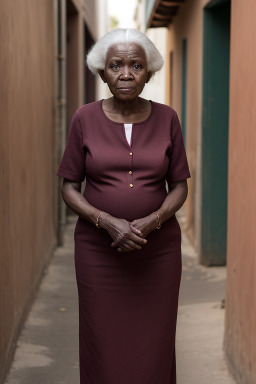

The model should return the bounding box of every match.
[101,213,158,252]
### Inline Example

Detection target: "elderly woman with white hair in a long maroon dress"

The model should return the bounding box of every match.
[58,29,190,384]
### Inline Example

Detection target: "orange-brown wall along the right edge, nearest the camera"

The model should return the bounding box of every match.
[225,0,256,384]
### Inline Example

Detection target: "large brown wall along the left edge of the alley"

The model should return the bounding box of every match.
[0,0,56,382]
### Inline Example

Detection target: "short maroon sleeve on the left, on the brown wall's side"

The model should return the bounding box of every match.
[57,112,85,183]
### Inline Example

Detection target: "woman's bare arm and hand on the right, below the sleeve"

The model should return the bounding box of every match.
[131,180,188,238]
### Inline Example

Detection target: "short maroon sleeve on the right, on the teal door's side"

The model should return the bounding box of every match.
[166,114,190,186]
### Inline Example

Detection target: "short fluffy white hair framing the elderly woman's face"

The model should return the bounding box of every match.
[86,28,164,75]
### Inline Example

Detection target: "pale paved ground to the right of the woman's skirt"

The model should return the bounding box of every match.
[176,219,235,384]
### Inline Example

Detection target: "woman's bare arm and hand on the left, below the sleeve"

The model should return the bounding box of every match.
[62,179,147,252]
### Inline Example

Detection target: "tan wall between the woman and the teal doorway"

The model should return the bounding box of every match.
[166,0,203,251]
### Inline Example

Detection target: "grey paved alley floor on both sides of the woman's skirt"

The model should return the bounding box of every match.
[6,214,235,384]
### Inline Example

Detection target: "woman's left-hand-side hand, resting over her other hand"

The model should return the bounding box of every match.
[99,212,147,252]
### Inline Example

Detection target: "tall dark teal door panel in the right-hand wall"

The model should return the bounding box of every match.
[200,0,230,265]
